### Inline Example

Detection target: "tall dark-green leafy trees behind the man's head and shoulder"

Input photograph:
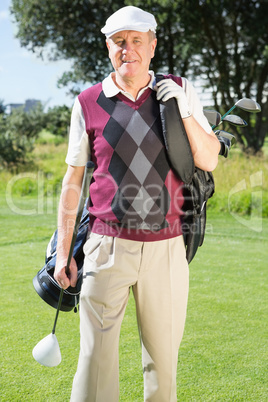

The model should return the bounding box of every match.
[12,0,268,153]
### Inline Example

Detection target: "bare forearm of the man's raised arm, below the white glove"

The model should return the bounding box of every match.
[182,116,220,172]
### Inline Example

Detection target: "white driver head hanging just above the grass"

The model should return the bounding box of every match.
[32,333,61,367]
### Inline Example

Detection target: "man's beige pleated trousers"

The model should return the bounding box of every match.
[71,233,189,402]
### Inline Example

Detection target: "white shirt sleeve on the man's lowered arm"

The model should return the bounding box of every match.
[65,98,90,166]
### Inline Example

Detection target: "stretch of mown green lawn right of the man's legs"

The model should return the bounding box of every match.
[179,215,268,401]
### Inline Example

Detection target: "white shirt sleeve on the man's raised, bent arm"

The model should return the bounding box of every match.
[182,77,212,134]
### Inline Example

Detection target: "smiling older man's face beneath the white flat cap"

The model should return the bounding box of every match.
[106,31,157,80]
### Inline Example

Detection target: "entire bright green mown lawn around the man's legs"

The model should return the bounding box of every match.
[0,195,268,402]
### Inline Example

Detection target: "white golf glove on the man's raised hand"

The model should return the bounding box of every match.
[156,78,191,119]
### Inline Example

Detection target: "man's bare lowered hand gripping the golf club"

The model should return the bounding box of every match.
[54,256,77,289]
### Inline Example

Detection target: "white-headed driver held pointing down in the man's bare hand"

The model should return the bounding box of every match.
[32,161,94,367]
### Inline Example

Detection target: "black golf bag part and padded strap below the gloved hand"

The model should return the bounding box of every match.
[156,74,214,263]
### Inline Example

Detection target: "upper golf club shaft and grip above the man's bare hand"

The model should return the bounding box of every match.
[65,161,95,273]
